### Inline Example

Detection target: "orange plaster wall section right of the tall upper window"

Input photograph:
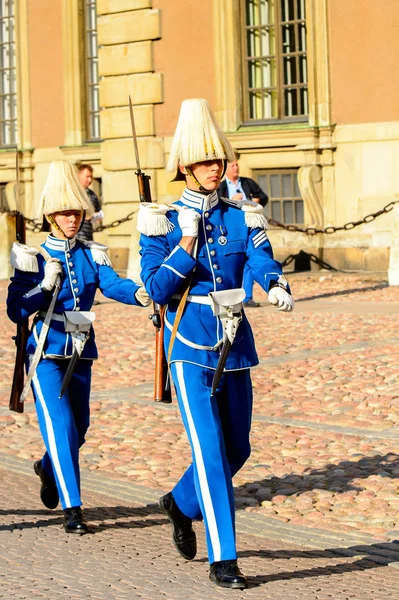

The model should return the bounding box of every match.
[328,0,399,124]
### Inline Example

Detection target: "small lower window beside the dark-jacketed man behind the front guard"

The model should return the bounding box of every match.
[255,169,304,225]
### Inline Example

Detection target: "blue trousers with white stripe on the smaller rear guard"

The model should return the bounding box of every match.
[32,359,92,508]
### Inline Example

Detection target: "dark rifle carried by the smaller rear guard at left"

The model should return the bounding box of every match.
[9,149,29,413]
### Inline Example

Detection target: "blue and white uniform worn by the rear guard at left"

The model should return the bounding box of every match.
[7,235,141,508]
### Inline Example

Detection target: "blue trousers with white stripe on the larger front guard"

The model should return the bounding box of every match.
[171,362,252,564]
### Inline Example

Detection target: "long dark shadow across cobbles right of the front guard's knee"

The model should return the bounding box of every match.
[236,453,399,498]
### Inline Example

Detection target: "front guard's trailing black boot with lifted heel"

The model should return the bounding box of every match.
[159,492,197,560]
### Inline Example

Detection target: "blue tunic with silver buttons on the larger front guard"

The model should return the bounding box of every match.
[140,189,282,370]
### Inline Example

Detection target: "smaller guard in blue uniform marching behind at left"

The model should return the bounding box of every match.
[7,161,150,534]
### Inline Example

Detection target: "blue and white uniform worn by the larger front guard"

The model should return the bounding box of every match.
[139,188,288,563]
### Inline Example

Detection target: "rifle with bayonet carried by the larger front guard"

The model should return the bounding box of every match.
[129,96,172,404]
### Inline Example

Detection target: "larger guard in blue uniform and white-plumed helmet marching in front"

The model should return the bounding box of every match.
[138,99,294,588]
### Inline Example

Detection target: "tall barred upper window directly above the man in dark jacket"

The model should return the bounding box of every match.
[241,0,309,123]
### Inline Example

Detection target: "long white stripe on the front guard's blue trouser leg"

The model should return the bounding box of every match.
[175,362,221,562]
